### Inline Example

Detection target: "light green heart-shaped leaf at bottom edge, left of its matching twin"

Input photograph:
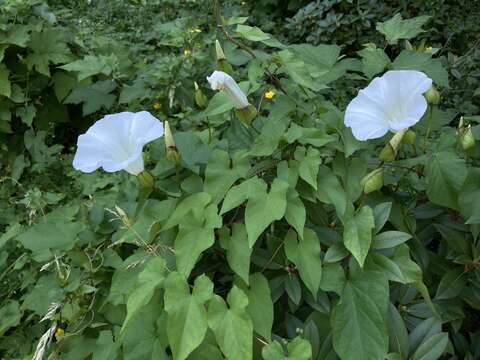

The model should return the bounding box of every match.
[165,272,213,360]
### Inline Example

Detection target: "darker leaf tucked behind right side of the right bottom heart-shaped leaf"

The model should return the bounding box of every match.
[237,273,273,340]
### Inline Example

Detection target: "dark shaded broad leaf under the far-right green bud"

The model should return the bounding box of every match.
[425,151,467,210]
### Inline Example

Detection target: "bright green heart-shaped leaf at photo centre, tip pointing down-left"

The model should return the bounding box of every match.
[245,178,288,247]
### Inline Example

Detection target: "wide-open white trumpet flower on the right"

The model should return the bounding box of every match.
[345,70,432,141]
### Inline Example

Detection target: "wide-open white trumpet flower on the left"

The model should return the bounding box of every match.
[73,111,163,175]
